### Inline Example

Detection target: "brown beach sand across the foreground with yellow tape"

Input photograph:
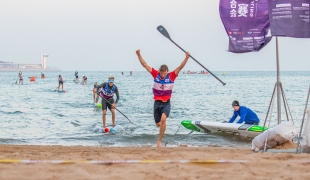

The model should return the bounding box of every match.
[0,145,310,180]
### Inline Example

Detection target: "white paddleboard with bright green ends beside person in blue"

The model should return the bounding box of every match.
[181,120,267,138]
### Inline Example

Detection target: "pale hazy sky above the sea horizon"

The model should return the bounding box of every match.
[0,0,310,71]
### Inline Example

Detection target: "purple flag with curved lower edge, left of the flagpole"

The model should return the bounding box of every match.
[219,0,272,53]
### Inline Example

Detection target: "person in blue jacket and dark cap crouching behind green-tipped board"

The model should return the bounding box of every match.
[228,100,259,125]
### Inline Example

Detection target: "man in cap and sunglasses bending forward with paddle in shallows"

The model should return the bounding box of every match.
[97,76,119,128]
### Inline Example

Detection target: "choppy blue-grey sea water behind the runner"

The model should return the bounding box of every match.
[0,71,310,148]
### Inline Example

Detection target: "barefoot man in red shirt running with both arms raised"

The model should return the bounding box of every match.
[136,49,190,147]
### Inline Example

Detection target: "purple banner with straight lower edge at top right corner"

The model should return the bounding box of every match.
[268,0,310,38]
